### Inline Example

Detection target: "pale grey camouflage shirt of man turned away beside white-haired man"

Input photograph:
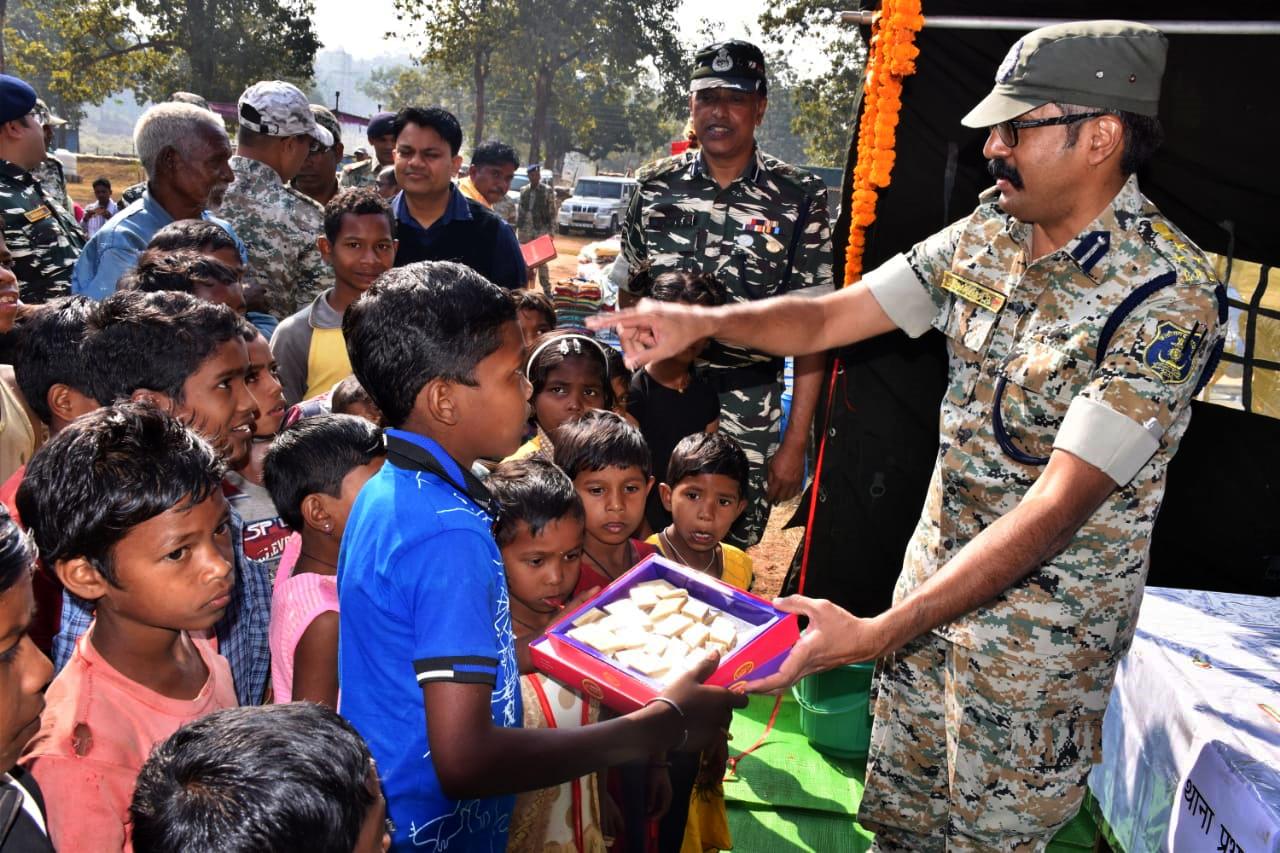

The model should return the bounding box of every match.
[218,155,333,319]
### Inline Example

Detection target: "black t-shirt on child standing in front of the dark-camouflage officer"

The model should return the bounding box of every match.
[627,369,719,533]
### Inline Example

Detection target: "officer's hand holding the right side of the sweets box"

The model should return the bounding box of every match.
[746,596,881,693]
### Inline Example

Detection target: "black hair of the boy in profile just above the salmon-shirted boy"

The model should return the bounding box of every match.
[83,291,241,405]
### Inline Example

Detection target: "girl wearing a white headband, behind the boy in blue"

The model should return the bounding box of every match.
[512,326,613,459]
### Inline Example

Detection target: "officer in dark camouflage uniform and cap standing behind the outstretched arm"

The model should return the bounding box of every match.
[613,41,832,547]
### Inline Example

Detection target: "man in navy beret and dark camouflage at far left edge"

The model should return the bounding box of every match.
[0,74,84,304]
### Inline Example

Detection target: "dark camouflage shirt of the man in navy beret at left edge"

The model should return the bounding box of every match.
[0,160,84,304]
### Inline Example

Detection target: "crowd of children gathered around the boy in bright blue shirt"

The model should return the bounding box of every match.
[0,183,768,853]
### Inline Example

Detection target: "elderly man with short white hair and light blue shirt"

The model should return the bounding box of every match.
[72,102,244,300]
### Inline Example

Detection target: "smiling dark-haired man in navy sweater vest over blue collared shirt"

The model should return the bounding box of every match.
[392,106,527,289]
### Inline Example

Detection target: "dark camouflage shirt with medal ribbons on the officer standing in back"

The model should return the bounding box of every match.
[618,150,832,368]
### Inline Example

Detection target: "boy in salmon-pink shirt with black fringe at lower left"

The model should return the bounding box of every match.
[18,403,236,850]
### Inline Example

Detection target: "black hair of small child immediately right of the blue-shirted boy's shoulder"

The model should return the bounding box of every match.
[485,457,586,548]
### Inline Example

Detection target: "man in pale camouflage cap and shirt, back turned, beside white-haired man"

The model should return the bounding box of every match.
[218,81,334,319]
